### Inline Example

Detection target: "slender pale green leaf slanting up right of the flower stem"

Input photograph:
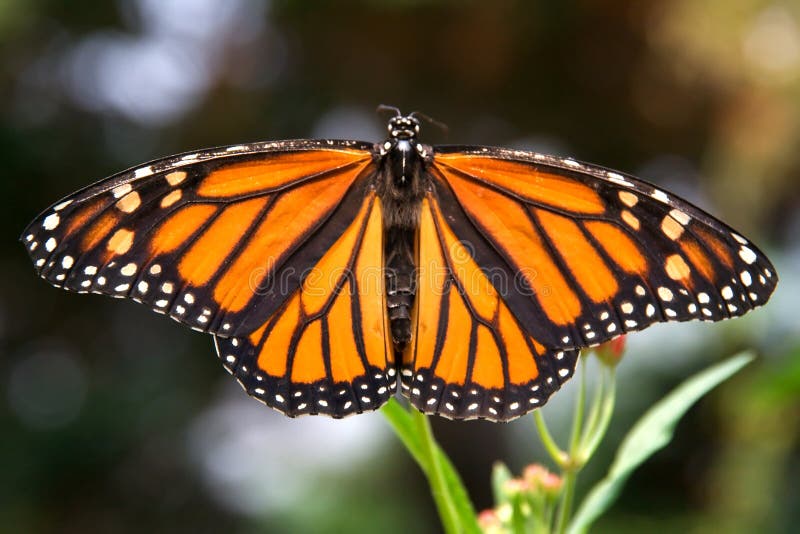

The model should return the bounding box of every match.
[568,353,753,534]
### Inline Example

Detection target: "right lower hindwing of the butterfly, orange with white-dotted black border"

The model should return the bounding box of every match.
[401,194,578,421]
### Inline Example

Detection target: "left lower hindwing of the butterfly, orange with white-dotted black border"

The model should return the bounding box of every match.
[216,192,397,417]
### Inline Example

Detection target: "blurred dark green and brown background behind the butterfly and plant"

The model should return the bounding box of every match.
[0,0,800,534]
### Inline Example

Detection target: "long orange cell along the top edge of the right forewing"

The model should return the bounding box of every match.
[436,154,606,215]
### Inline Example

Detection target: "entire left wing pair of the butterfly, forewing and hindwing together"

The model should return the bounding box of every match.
[23,141,395,417]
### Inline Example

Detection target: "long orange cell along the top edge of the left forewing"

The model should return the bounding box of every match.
[197,150,370,197]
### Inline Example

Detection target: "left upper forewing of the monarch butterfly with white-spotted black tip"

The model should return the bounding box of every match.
[23,141,373,336]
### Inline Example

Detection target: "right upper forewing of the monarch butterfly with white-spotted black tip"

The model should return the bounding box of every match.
[431,147,777,349]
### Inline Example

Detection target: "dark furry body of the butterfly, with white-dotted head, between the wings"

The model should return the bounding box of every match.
[377,116,430,352]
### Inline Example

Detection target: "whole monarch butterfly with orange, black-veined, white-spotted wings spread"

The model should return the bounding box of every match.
[21,108,777,421]
